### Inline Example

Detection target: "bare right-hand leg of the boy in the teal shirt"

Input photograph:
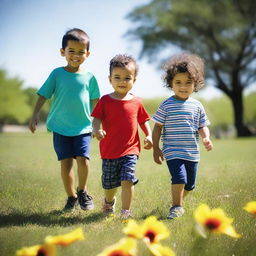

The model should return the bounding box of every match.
[76,156,90,191]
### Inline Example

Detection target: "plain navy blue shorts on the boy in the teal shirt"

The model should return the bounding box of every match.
[53,132,91,160]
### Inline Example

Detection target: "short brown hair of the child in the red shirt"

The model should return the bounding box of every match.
[109,54,139,77]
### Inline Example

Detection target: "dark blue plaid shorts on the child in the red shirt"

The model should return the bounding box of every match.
[101,155,139,189]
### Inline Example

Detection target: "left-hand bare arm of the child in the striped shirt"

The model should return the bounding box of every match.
[152,123,164,164]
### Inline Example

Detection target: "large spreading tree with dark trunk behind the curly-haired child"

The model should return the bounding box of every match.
[127,0,256,136]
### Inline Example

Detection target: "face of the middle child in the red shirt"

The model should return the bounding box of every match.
[109,63,136,97]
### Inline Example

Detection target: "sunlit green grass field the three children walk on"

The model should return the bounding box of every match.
[0,132,256,256]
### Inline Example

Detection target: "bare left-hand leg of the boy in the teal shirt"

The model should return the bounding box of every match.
[60,158,76,197]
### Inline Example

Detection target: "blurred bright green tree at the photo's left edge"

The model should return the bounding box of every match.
[0,70,32,131]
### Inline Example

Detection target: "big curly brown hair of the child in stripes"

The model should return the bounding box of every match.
[163,52,204,92]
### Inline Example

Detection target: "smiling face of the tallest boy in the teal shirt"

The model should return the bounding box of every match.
[60,40,90,71]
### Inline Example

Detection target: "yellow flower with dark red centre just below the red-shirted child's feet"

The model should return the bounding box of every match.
[141,216,170,243]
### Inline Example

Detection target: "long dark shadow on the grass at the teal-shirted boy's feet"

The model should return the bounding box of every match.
[0,210,104,227]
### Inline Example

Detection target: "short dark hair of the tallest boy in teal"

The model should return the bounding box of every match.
[62,28,90,51]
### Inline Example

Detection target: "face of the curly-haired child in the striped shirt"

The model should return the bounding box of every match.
[171,72,195,100]
